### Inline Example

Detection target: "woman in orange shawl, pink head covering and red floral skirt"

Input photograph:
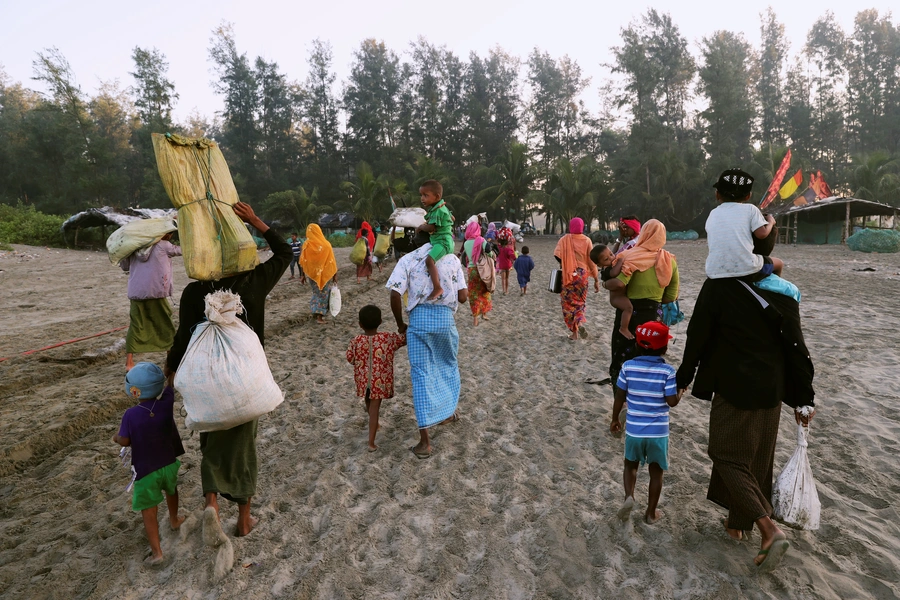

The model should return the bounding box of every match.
[553,217,600,340]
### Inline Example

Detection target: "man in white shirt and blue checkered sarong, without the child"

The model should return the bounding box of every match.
[386,232,469,458]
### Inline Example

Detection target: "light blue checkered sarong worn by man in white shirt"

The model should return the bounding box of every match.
[406,304,460,429]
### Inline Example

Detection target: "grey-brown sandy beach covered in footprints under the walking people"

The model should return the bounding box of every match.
[0,236,900,600]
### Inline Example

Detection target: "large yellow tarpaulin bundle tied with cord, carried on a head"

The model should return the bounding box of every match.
[153,133,259,281]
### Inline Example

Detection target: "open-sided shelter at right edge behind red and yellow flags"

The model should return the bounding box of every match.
[767,196,898,244]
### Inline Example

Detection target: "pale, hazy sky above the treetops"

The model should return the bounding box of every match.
[0,0,896,121]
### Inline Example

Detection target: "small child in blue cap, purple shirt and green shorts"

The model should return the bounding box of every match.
[113,362,184,565]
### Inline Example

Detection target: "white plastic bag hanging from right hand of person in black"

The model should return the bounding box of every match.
[772,418,822,530]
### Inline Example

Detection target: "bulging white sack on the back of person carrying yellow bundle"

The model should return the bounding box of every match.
[175,290,284,431]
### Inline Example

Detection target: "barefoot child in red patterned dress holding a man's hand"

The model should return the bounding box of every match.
[347,304,406,452]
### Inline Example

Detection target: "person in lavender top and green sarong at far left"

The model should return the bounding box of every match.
[119,225,181,371]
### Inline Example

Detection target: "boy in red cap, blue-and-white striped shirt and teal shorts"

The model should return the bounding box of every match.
[609,321,681,525]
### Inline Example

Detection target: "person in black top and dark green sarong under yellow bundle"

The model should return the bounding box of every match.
[166,202,290,544]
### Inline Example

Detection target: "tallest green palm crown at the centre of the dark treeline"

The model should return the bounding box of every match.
[475,142,536,219]
